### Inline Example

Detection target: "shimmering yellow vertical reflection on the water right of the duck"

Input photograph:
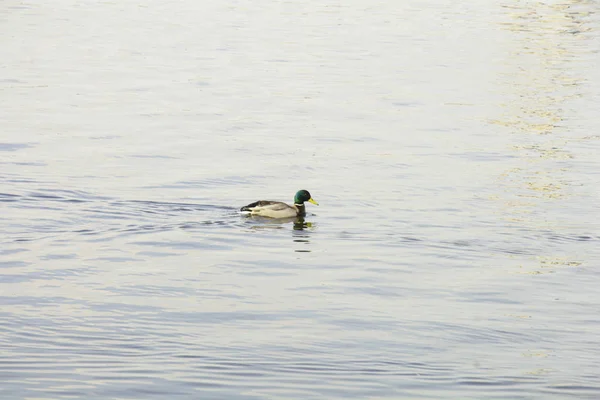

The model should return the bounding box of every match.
[489,0,594,274]
